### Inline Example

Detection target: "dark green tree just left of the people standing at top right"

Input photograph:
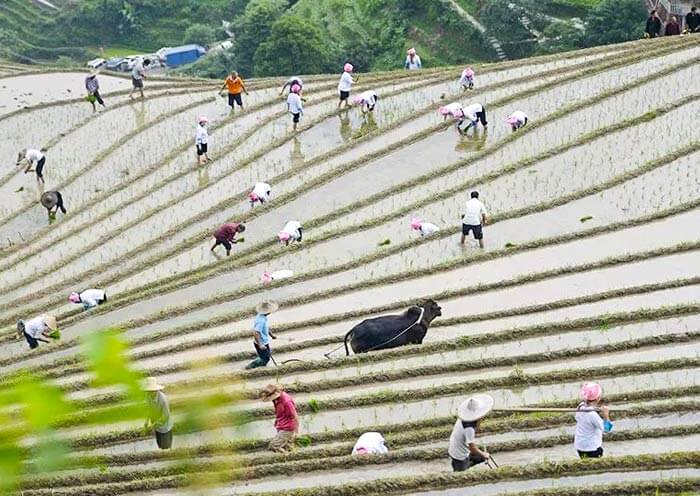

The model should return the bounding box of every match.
[584,0,647,46]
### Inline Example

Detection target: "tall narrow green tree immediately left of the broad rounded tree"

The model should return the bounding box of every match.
[233,0,288,76]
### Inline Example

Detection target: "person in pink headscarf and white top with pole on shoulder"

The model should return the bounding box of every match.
[574,382,613,458]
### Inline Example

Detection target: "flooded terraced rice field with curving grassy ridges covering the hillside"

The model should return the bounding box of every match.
[0,37,700,496]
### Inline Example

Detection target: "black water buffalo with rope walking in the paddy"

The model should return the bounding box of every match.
[345,300,442,355]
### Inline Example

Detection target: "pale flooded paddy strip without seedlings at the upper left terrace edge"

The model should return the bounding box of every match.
[0,72,131,115]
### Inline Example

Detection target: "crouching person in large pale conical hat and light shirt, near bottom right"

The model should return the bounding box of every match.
[447,394,493,472]
